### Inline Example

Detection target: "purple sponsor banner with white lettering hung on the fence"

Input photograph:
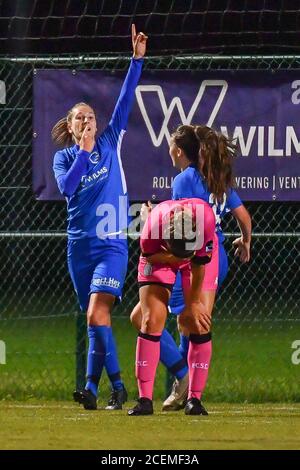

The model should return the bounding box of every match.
[33,70,300,201]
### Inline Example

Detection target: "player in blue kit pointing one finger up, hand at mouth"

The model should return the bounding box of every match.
[52,25,147,409]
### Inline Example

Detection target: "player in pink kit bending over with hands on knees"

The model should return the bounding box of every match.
[128,199,216,415]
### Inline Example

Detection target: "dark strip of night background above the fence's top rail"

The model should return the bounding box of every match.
[0,0,300,55]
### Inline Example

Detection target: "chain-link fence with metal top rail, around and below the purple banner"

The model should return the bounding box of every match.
[0,55,300,402]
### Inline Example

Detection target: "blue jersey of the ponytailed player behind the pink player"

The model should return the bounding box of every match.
[172,165,242,242]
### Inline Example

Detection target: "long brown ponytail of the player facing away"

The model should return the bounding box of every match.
[194,126,237,202]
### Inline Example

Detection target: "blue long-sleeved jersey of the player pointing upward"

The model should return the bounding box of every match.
[53,59,143,243]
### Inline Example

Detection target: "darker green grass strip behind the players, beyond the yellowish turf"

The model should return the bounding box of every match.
[0,316,300,403]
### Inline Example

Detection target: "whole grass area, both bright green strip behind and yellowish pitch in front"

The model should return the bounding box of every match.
[0,315,300,450]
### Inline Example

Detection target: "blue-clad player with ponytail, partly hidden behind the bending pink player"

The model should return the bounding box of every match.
[131,125,251,413]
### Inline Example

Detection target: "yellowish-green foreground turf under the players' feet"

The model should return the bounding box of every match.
[0,401,300,450]
